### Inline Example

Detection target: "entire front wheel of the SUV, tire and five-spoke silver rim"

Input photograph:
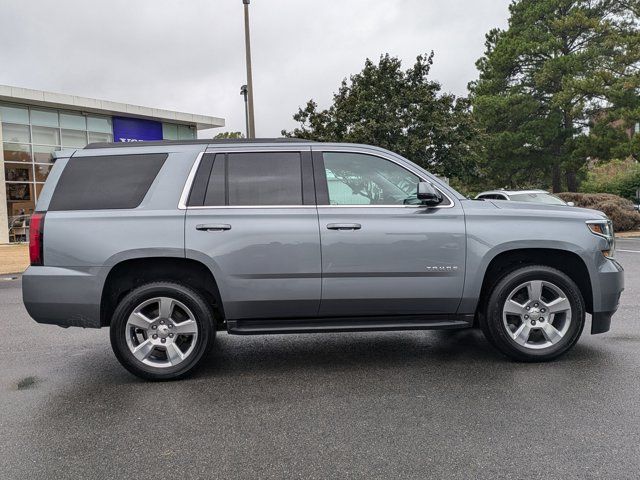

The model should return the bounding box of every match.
[481,265,585,362]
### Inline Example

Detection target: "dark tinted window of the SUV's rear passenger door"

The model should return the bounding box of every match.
[189,152,304,206]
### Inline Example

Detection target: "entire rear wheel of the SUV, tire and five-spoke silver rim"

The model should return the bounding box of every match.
[111,282,215,380]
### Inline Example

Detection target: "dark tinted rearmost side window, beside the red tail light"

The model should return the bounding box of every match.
[49,153,168,211]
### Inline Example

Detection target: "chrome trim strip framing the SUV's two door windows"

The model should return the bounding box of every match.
[178,145,456,210]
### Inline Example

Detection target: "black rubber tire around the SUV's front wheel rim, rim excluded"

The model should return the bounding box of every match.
[480,265,585,362]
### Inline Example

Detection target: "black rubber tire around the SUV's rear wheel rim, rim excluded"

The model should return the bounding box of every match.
[110,282,216,381]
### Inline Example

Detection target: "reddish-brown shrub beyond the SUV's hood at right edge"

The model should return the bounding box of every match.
[558,193,640,232]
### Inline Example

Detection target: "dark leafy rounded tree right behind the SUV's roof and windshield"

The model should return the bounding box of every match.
[282,52,477,183]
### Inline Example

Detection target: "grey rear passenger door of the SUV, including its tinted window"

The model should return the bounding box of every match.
[185,146,321,320]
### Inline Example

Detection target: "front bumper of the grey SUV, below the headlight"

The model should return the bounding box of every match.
[591,260,624,335]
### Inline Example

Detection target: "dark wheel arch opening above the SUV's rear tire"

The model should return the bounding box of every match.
[100,257,225,328]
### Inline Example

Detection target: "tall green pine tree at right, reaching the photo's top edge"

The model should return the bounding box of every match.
[470,0,640,191]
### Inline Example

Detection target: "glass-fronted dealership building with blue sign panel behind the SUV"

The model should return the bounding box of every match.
[0,85,224,243]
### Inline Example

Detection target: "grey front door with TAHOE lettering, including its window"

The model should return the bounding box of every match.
[314,147,466,317]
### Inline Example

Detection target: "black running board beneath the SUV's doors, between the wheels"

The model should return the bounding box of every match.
[227,315,473,335]
